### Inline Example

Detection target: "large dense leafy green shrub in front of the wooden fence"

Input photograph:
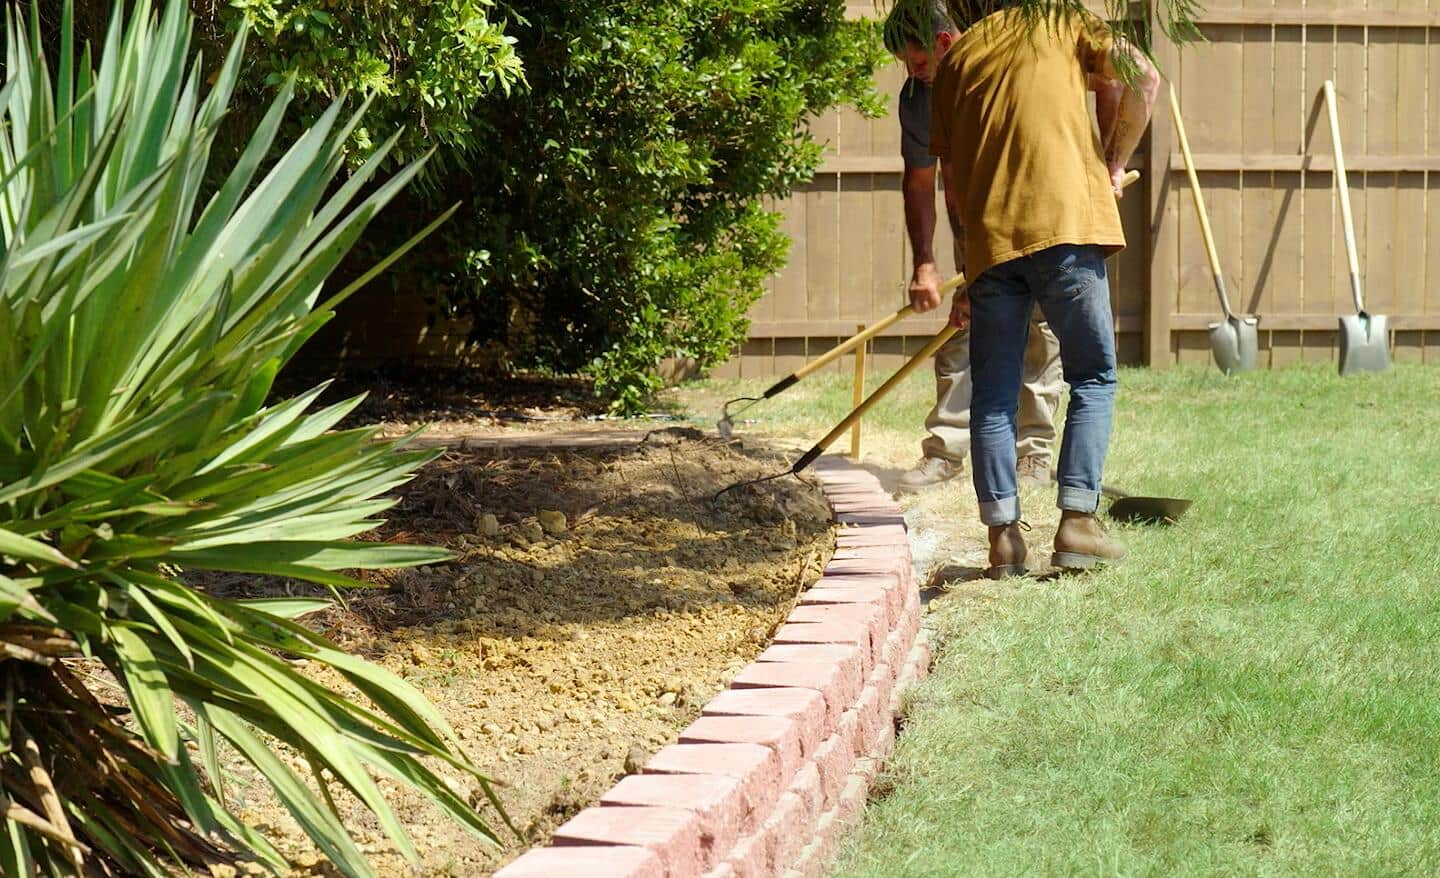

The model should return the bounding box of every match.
[213,0,883,412]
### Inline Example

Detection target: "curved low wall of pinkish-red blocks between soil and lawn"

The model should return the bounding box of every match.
[495,458,930,878]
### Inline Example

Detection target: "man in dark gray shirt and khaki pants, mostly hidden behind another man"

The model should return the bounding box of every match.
[884,0,1063,491]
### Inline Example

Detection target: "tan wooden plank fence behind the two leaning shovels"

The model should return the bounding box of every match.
[713,0,1440,377]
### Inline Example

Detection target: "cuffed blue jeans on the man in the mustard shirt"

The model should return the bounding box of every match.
[971,245,1116,525]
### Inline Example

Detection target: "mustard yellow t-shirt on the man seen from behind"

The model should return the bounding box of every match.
[930,10,1125,279]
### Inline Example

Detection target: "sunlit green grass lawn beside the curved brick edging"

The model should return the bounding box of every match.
[679,366,1440,878]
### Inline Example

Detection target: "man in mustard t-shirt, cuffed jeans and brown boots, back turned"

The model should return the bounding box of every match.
[930,0,1159,579]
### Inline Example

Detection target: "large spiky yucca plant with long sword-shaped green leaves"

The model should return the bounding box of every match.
[0,0,503,877]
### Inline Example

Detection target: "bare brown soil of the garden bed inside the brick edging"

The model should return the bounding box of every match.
[218,430,831,875]
